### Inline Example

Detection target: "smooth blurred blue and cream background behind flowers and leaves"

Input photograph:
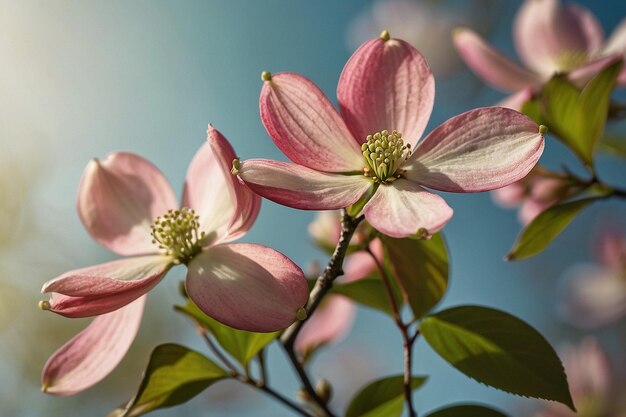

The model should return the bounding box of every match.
[0,0,626,417]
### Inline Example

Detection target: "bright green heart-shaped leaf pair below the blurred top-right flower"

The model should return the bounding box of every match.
[542,61,622,166]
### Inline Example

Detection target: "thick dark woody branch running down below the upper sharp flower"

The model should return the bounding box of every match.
[280,210,363,417]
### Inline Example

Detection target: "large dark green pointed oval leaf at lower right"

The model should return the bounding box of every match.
[420,306,575,411]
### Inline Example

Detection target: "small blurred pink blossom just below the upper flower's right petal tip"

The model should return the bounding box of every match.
[491,167,579,225]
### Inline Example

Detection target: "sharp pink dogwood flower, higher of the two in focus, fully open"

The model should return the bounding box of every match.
[233,31,544,237]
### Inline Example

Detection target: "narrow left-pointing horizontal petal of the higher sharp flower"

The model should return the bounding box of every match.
[238,159,372,210]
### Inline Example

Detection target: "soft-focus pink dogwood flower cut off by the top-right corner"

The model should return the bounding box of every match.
[454,0,626,109]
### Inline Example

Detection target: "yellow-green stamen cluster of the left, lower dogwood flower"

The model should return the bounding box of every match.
[150,207,205,263]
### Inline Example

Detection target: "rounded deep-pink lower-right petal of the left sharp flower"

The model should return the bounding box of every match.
[186,243,309,332]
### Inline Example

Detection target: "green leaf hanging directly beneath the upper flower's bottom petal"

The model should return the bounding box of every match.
[382,233,448,319]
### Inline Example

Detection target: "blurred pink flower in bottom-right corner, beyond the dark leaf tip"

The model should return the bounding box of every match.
[535,338,612,417]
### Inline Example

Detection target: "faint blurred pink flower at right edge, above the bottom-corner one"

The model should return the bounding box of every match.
[558,230,626,329]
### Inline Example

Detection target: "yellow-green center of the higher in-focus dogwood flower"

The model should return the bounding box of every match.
[361,130,411,184]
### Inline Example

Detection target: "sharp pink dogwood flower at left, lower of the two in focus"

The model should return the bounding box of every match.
[40,126,308,395]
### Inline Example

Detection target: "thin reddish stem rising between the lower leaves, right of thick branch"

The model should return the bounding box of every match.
[365,246,419,417]
